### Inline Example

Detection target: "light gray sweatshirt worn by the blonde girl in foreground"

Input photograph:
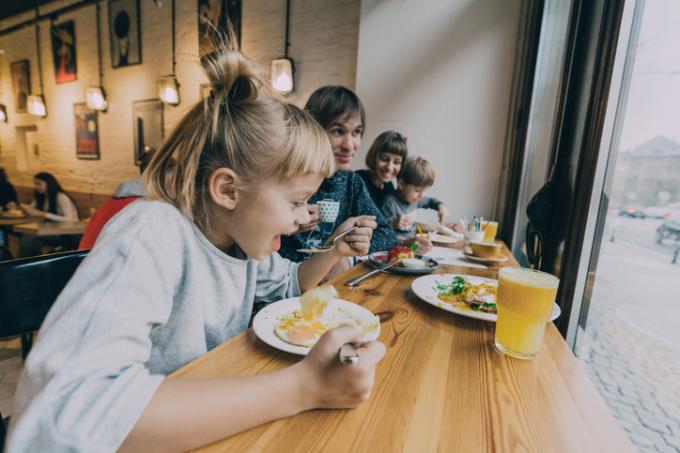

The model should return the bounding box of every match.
[7,200,300,452]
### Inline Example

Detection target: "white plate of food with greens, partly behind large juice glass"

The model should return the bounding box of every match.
[411,274,560,322]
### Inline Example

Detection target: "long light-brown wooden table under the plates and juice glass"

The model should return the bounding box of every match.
[171,246,633,453]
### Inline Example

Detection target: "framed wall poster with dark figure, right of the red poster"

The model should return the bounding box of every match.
[109,0,142,68]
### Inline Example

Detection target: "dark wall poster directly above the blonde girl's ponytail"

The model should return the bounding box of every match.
[197,0,241,59]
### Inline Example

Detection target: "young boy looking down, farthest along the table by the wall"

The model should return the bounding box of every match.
[382,156,449,235]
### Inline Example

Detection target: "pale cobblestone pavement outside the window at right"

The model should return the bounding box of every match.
[577,238,680,452]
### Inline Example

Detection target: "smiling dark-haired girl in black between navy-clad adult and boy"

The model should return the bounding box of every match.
[355,131,408,208]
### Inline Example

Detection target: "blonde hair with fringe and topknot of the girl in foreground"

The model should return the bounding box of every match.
[146,40,335,227]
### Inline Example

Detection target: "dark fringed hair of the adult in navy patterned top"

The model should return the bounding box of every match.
[305,85,366,134]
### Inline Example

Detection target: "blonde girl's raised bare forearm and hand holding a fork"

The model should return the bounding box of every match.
[298,216,377,291]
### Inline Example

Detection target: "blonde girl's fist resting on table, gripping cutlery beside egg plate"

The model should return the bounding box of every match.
[294,327,385,409]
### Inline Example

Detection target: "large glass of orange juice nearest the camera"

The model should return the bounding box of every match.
[496,267,560,360]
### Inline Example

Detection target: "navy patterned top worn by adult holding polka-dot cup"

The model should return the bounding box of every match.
[279,171,397,262]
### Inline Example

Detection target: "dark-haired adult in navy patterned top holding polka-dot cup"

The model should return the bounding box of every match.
[279,86,397,264]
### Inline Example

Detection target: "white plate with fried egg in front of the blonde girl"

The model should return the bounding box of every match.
[253,285,380,355]
